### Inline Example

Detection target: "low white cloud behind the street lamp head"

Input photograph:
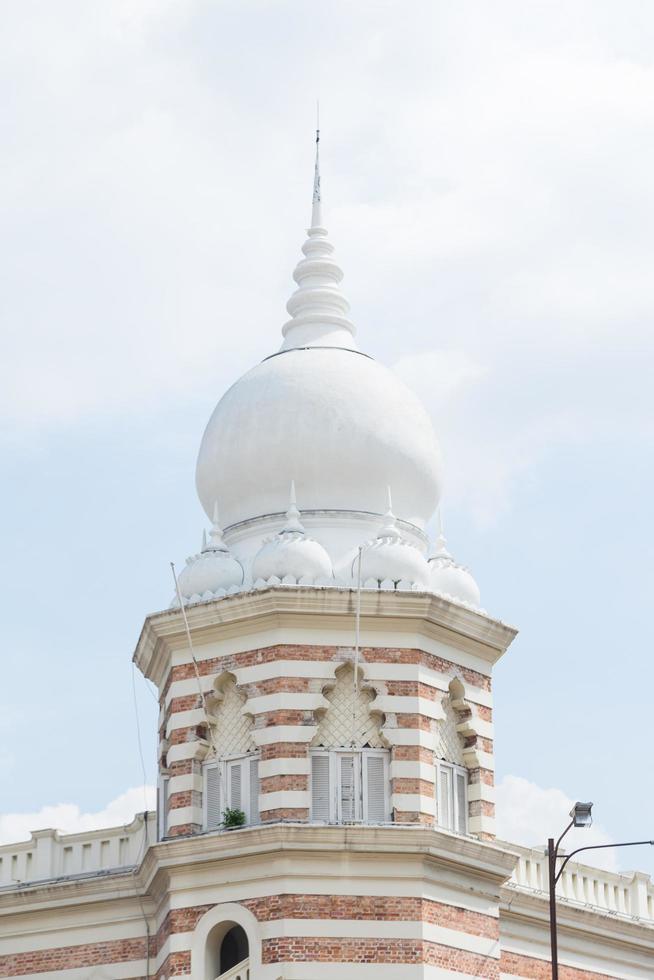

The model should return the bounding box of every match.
[496,776,618,871]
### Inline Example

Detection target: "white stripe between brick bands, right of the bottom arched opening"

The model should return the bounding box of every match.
[261,919,500,959]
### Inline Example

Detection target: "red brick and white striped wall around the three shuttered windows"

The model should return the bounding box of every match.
[160,644,494,839]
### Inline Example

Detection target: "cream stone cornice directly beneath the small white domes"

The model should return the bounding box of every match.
[133,585,517,683]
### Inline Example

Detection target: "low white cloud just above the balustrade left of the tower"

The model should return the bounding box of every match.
[0,786,156,844]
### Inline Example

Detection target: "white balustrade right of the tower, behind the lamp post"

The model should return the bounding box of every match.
[508,842,654,921]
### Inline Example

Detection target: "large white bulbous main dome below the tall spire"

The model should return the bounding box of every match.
[196,347,440,528]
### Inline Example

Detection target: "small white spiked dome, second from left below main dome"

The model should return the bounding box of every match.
[252,484,334,583]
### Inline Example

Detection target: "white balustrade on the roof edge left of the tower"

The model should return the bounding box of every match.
[0,813,156,888]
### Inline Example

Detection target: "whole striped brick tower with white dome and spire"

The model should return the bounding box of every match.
[134,132,515,980]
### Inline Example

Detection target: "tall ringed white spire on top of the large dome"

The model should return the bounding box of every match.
[281,129,357,350]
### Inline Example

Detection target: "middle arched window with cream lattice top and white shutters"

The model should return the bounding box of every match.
[310,664,390,823]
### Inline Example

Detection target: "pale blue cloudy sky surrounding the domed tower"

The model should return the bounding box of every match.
[0,0,654,873]
